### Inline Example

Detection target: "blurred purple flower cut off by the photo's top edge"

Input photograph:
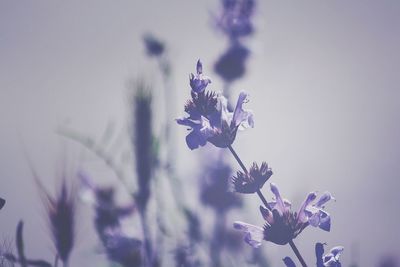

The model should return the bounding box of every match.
[216,0,255,39]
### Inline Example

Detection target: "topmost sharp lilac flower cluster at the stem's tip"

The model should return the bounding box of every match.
[177,60,254,150]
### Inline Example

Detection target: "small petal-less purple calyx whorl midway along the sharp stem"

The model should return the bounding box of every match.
[232,162,273,194]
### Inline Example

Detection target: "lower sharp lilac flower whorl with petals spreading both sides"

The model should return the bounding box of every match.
[234,183,332,247]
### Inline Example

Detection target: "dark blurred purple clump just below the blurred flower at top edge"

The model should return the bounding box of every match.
[214,42,250,82]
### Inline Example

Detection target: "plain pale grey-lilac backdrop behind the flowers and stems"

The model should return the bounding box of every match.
[0,0,400,266]
